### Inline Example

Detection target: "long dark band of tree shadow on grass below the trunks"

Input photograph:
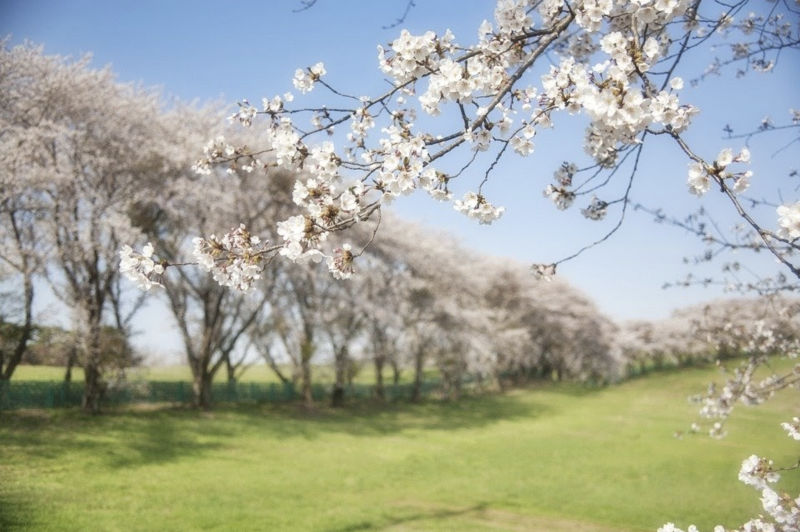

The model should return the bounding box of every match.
[0,394,552,468]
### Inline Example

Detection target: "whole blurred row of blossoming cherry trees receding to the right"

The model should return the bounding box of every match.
[0,43,798,412]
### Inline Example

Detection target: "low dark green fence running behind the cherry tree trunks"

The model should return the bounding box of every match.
[0,381,450,410]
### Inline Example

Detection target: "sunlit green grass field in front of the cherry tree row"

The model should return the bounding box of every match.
[0,364,800,532]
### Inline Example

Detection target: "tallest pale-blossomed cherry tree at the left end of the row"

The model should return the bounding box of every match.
[0,42,191,412]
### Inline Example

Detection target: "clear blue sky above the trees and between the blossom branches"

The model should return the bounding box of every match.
[0,0,800,358]
